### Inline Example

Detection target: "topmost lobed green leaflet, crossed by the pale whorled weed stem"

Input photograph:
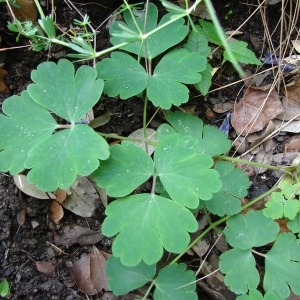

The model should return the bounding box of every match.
[109,3,188,59]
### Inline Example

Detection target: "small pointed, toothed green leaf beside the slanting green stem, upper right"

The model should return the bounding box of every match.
[223,41,261,66]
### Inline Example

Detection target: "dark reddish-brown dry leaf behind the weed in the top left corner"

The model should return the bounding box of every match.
[8,0,38,23]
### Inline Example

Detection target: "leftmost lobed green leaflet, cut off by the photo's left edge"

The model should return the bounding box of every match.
[0,91,57,174]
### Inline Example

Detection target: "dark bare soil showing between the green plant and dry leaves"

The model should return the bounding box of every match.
[0,0,294,300]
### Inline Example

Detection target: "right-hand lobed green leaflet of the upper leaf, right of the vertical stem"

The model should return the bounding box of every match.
[147,49,206,109]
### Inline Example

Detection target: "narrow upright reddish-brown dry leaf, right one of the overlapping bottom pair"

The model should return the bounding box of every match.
[89,246,109,293]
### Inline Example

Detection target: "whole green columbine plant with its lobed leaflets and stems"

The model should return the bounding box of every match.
[0,1,300,300]
